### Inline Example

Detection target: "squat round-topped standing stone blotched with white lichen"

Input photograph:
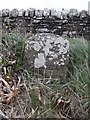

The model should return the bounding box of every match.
[25,33,69,80]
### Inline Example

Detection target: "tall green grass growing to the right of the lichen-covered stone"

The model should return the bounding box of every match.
[65,38,90,117]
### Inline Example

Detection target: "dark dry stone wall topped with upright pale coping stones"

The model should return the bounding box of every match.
[0,8,90,39]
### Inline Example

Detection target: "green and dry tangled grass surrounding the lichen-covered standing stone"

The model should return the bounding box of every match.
[1,33,90,119]
